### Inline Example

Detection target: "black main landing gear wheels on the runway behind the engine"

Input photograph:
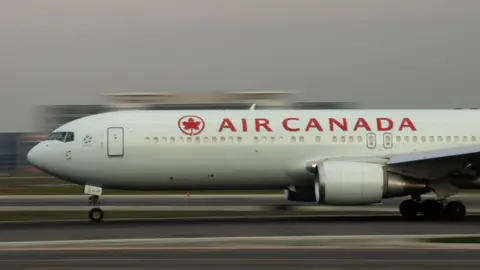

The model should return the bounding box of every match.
[400,198,466,220]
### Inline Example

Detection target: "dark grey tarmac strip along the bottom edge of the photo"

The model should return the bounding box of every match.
[0,248,480,270]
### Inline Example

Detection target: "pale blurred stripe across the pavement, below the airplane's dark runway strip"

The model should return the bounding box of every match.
[0,234,480,251]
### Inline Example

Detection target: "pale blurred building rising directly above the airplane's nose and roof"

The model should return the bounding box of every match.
[37,91,355,133]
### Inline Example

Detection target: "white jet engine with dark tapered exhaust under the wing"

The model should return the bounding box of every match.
[314,161,428,205]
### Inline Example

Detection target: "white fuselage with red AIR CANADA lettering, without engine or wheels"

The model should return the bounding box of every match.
[29,110,480,190]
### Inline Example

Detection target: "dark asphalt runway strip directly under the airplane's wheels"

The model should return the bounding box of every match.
[0,216,480,242]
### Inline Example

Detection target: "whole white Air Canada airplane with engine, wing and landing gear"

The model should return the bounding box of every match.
[27,109,480,222]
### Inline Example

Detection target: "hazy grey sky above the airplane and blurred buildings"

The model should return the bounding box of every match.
[0,0,480,132]
